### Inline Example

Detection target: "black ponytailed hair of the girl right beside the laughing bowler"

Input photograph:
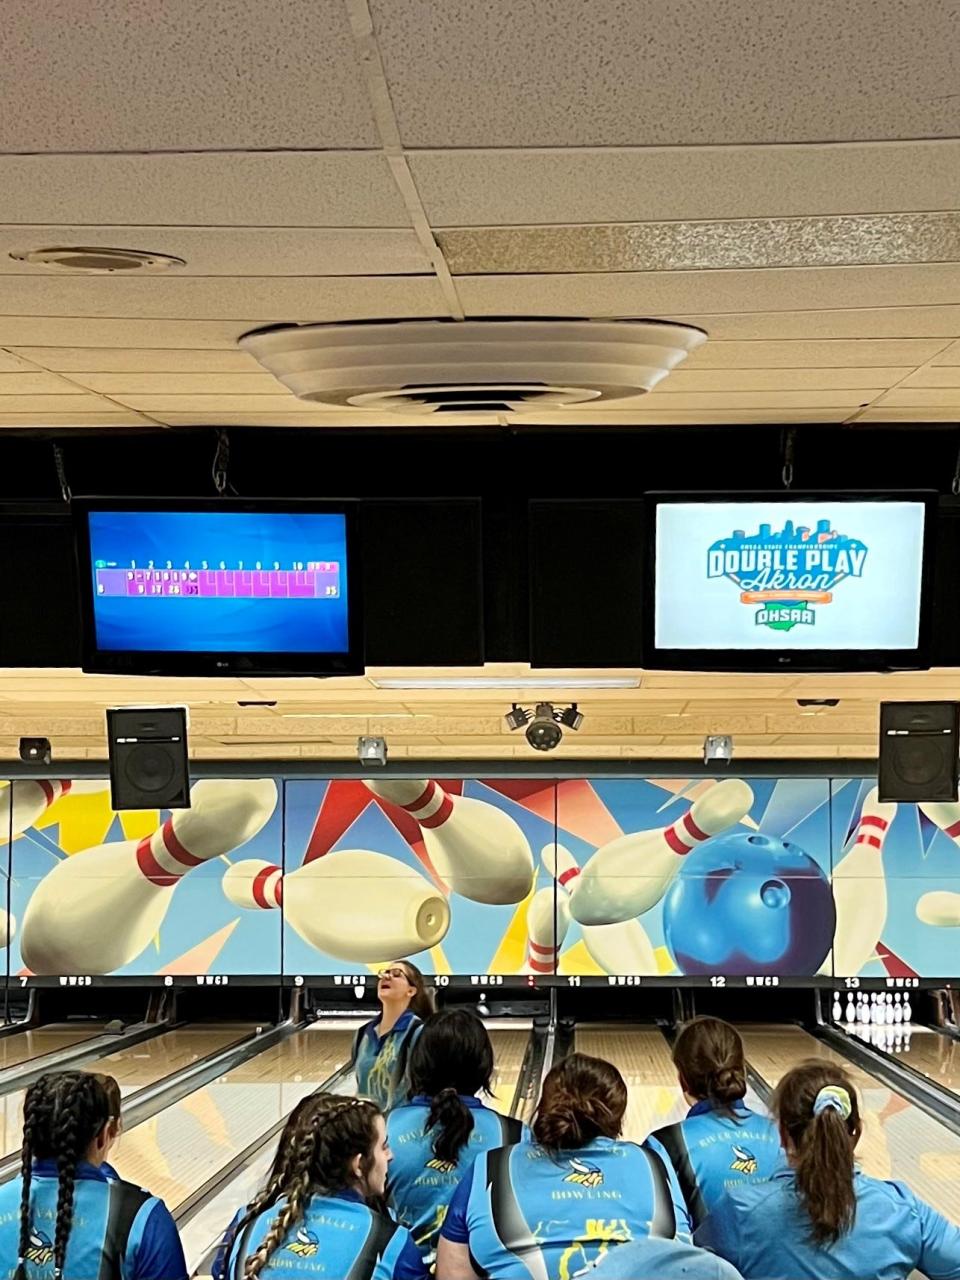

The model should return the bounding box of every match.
[410,1009,493,1165]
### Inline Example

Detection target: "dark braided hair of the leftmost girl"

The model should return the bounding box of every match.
[14,1071,110,1280]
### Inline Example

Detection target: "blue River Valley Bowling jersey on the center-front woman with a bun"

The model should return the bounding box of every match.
[440,1138,690,1280]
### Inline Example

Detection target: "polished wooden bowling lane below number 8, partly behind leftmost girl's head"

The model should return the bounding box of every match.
[0,1023,255,1156]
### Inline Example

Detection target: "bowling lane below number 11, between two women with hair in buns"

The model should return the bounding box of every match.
[575,1025,687,1142]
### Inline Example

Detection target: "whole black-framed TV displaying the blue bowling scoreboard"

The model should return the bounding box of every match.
[74,498,364,676]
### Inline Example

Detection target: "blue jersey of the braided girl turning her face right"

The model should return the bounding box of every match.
[224,1190,426,1280]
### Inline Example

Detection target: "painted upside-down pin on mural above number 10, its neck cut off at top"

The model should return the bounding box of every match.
[365,778,535,904]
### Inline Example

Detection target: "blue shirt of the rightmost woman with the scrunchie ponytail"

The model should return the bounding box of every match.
[704,1169,960,1280]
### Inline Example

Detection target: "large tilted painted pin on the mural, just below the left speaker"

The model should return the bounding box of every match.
[20,778,276,974]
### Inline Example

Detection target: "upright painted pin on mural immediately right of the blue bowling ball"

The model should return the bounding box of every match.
[832,787,897,977]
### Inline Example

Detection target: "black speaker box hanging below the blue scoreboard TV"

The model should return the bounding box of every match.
[106,707,189,809]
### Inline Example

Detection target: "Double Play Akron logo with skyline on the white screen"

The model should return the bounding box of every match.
[707,520,867,631]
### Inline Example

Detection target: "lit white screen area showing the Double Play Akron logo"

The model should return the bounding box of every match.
[654,495,927,653]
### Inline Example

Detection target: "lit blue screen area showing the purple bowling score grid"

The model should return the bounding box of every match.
[86,509,351,654]
